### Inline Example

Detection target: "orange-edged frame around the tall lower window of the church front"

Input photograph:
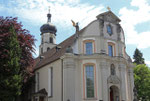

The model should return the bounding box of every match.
[83,63,97,100]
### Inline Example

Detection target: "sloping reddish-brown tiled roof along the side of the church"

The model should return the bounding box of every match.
[34,34,77,71]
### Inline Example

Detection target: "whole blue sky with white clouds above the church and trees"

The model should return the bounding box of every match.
[0,0,150,66]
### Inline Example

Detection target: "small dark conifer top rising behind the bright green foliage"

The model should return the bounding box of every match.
[133,48,145,65]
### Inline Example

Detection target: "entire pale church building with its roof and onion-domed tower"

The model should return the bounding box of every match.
[32,11,134,101]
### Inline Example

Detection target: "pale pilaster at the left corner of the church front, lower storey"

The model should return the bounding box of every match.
[63,53,75,101]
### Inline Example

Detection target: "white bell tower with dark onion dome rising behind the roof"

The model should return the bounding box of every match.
[39,9,57,55]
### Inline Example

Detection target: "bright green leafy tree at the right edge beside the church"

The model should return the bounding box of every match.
[134,64,150,101]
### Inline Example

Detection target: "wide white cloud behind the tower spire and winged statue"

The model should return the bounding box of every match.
[2,0,104,27]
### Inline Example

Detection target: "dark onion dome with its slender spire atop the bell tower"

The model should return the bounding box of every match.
[40,9,57,35]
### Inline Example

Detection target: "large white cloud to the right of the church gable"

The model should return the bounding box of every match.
[119,0,150,49]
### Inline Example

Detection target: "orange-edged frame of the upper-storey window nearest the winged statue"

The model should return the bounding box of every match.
[83,39,96,55]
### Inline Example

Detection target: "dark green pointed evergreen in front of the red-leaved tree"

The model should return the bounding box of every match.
[0,26,22,101]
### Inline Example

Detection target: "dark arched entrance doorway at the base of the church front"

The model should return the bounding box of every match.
[109,86,120,101]
